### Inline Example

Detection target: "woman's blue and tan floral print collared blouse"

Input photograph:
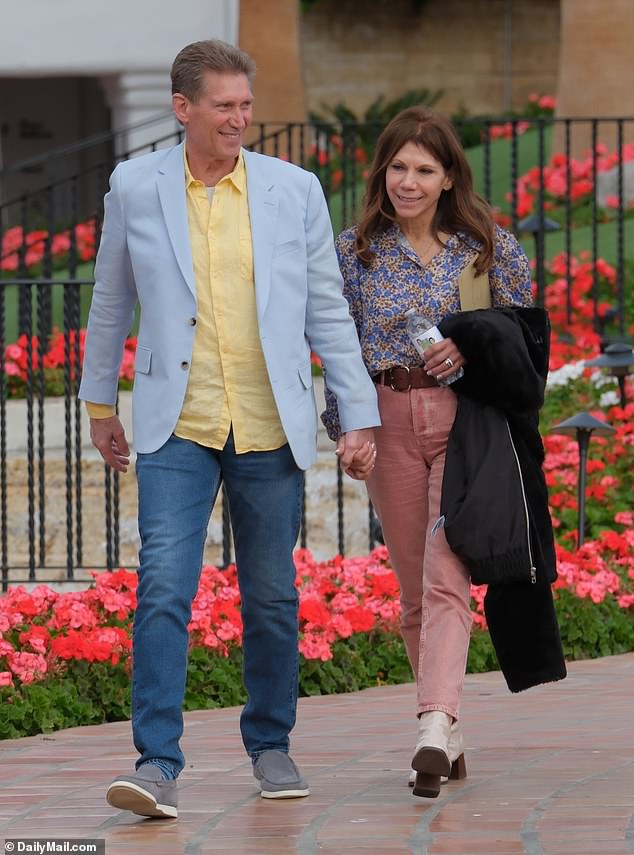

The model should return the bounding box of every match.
[321,225,532,439]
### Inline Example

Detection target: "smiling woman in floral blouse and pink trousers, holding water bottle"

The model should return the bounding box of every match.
[323,107,531,797]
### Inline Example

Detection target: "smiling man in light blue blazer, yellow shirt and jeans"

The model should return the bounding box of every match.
[79,40,379,817]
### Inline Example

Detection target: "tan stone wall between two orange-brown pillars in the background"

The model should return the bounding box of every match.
[301,0,559,114]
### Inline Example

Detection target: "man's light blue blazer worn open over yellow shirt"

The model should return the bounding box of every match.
[79,143,380,469]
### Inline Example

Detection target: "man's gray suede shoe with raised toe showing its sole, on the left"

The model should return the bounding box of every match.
[106,763,178,819]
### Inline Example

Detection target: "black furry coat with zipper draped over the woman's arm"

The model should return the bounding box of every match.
[439,307,566,692]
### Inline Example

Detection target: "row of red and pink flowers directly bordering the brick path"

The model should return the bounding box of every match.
[0,524,634,738]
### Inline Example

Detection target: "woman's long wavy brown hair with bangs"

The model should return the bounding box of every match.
[356,107,494,274]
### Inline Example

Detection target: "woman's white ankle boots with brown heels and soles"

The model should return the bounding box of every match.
[409,710,467,798]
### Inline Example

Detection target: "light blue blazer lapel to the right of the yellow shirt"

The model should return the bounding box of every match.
[244,151,279,319]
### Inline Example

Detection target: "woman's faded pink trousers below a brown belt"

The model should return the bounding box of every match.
[366,385,471,719]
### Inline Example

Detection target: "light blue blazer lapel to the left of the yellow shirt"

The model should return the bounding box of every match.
[157,143,196,295]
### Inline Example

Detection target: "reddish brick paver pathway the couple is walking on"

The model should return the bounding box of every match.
[0,654,634,855]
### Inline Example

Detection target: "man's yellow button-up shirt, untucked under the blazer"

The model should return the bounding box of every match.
[174,154,286,453]
